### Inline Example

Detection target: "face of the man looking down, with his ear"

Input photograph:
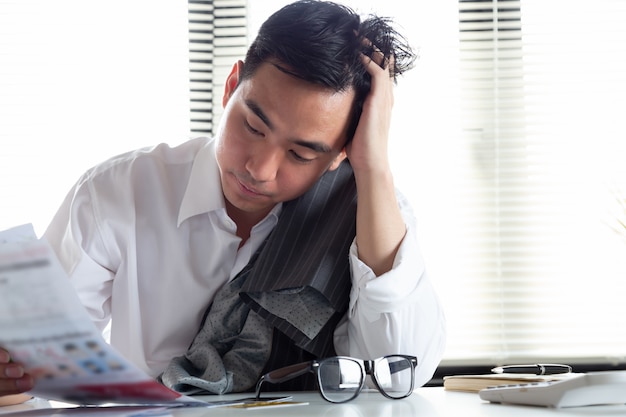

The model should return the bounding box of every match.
[217,62,354,221]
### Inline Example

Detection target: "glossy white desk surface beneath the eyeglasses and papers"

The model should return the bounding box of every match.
[0,387,626,417]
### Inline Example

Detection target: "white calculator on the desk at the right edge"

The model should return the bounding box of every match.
[478,371,626,411]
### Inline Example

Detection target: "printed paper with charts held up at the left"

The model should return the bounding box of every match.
[0,225,199,405]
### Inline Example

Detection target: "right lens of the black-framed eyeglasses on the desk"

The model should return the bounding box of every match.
[374,356,413,398]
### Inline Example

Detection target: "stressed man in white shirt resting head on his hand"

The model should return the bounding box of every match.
[0,0,445,404]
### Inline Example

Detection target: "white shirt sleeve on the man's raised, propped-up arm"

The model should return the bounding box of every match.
[334,190,446,386]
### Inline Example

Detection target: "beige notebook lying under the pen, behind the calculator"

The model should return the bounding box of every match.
[443,373,579,392]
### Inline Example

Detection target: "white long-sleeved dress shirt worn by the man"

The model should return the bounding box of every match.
[44,138,445,386]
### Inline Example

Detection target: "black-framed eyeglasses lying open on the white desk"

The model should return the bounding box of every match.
[256,355,417,403]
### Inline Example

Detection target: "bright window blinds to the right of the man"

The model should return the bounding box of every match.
[444,0,626,364]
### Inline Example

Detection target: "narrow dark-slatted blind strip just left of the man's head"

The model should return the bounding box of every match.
[189,0,247,135]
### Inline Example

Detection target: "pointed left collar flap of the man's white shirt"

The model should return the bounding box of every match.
[178,140,226,226]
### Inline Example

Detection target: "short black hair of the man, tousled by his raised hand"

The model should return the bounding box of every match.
[240,0,416,140]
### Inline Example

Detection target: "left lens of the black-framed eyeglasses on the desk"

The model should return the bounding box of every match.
[318,358,363,403]
